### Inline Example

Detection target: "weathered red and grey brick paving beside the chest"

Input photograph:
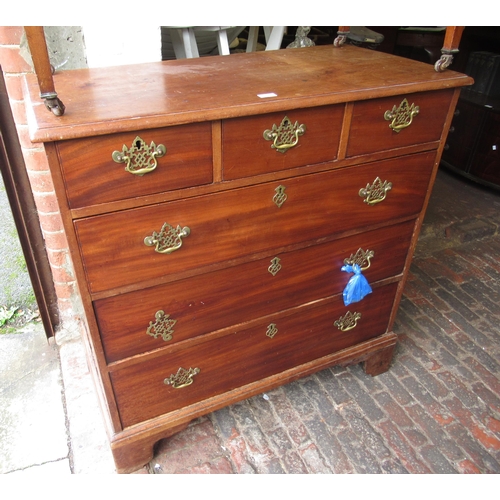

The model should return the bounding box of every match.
[138,167,500,474]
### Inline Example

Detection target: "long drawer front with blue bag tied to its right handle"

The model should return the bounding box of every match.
[94,221,414,362]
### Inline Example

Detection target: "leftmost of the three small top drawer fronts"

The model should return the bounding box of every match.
[57,123,213,208]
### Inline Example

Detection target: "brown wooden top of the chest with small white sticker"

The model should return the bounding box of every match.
[26,45,472,142]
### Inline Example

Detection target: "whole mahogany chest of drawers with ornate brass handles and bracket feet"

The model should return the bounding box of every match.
[26,46,471,472]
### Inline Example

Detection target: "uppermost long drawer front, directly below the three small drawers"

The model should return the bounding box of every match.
[75,152,435,292]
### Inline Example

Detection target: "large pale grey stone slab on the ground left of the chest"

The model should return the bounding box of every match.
[0,323,69,473]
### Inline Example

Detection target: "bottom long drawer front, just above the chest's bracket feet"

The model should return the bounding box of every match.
[111,283,397,427]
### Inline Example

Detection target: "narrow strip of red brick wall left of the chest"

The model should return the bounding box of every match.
[0,26,78,321]
